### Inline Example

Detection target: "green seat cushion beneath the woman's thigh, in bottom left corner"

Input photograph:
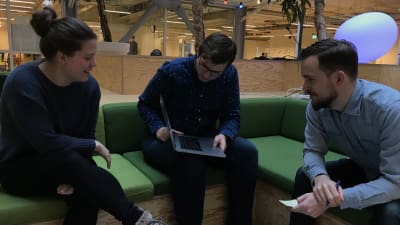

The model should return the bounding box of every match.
[0,191,67,225]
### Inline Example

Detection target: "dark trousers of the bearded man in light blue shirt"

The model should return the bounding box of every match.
[290,159,400,225]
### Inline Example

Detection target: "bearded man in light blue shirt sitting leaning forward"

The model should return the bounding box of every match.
[290,40,400,225]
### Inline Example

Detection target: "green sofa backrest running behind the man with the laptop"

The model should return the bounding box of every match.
[96,97,342,156]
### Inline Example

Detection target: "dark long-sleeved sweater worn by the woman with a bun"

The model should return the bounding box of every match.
[0,61,100,168]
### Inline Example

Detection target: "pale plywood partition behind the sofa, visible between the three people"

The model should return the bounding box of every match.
[93,54,400,95]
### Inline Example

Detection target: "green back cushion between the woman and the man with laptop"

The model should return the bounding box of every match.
[102,102,146,153]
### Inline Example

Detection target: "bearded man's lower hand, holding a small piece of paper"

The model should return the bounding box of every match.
[292,192,328,218]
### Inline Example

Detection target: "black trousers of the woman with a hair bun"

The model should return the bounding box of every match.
[1,151,142,225]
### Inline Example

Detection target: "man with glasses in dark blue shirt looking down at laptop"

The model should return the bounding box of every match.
[138,33,258,225]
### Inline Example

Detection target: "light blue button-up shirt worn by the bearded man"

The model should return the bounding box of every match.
[303,80,400,209]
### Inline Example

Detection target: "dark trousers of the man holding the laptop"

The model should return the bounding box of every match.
[143,137,258,225]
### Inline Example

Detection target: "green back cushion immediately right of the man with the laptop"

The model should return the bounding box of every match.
[239,98,286,138]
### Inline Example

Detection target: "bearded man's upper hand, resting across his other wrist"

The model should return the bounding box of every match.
[313,175,344,207]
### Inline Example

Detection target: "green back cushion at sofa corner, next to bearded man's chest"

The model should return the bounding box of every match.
[280,98,308,142]
